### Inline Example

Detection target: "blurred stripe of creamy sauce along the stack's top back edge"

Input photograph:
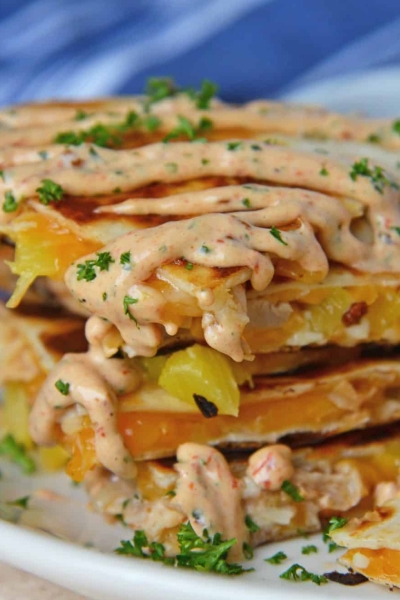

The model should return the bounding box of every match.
[0,95,400,149]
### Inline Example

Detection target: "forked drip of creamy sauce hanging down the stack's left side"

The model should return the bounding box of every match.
[30,318,141,478]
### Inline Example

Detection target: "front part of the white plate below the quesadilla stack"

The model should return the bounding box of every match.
[0,462,393,600]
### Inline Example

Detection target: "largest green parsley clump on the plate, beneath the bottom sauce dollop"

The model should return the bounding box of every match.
[115,523,248,575]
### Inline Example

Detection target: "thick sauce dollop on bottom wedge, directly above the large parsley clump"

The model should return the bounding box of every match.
[173,443,249,560]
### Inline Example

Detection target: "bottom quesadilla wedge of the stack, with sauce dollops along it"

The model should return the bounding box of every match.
[81,430,400,555]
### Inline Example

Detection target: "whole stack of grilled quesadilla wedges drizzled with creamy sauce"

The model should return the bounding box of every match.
[0,79,400,568]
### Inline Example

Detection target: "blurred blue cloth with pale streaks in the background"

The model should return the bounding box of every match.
[0,0,400,105]
